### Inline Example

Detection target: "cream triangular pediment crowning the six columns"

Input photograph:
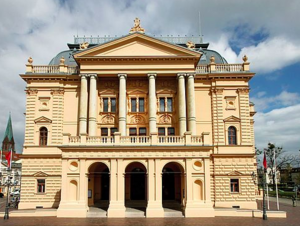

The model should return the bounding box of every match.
[74,33,201,59]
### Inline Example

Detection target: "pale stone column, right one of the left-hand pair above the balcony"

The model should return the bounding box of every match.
[89,74,98,136]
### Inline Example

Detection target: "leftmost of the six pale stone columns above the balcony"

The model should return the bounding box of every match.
[79,75,88,135]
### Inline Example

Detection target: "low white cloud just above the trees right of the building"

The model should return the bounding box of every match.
[254,104,300,153]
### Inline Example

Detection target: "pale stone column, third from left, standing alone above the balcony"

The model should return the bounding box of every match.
[118,74,127,136]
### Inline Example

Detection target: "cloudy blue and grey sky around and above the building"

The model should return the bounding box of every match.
[0,0,300,153]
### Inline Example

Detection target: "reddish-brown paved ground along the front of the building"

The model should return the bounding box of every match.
[0,202,300,226]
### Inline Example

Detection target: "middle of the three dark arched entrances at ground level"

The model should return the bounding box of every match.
[125,162,147,213]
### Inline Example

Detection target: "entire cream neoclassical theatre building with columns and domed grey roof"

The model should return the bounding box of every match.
[19,19,257,217]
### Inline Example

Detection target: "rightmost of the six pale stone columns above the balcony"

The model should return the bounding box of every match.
[187,74,196,135]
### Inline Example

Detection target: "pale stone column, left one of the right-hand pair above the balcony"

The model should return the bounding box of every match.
[177,74,186,136]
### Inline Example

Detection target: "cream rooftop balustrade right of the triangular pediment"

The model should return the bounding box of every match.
[196,64,245,74]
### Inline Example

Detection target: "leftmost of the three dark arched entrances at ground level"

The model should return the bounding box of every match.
[88,162,110,210]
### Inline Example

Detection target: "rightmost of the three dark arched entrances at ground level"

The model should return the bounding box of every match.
[162,162,184,209]
